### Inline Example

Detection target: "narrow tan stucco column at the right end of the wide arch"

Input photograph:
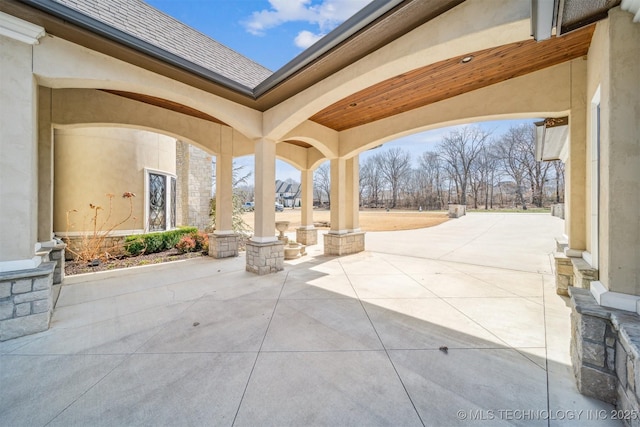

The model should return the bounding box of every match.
[565,57,588,258]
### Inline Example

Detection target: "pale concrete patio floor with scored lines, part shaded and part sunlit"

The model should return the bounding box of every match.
[0,213,619,426]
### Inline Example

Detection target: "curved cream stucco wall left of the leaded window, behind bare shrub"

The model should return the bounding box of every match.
[53,128,176,235]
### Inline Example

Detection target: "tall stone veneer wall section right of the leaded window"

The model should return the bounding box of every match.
[176,141,213,230]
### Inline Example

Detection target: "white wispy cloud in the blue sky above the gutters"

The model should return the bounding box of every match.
[243,0,371,41]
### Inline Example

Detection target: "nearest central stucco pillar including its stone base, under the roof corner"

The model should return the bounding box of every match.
[246,138,284,275]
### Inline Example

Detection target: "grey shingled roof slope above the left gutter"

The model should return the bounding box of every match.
[54,0,273,89]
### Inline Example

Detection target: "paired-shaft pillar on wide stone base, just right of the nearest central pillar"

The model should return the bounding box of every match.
[324,157,365,255]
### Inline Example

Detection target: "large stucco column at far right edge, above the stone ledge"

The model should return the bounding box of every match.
[600,8,640,296]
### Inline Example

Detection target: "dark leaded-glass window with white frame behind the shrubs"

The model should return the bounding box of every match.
[145,170,176,231]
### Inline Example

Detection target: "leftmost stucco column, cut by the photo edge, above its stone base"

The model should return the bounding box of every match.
[0,32,40,272]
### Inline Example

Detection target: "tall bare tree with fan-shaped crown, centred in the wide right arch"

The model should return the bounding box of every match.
[438,126,490,205]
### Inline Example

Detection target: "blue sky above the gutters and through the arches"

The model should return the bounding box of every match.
[145,0,534,181]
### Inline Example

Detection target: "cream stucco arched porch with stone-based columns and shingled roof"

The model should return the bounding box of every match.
[0,0,640,413]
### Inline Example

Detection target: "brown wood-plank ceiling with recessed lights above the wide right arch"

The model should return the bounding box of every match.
[310,25,594,131]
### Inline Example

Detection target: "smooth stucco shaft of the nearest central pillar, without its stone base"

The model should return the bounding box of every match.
[252,138,277,242]
